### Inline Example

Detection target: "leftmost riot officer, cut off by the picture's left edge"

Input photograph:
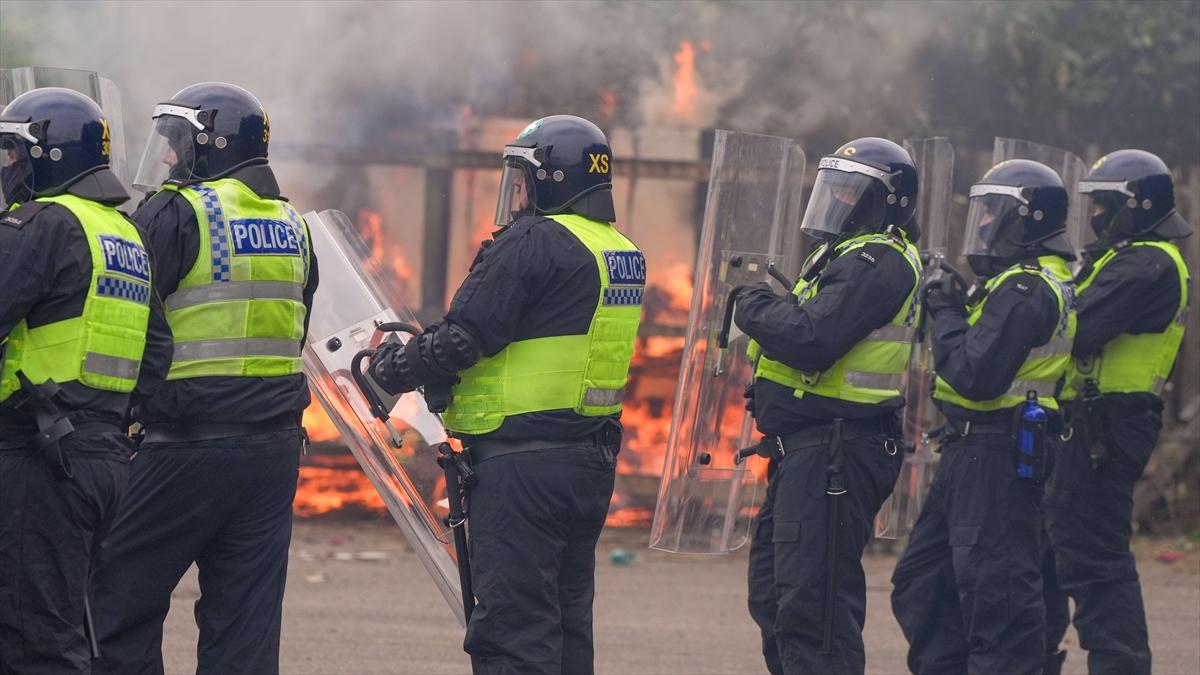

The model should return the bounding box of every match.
[0,88,151,674]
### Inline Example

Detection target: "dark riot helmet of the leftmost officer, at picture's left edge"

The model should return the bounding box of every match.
[0,86,127,204]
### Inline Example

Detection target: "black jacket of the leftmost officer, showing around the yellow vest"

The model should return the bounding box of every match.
[0,180,138,441]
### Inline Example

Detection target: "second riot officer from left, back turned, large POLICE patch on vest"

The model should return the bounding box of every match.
[96,83,317,673]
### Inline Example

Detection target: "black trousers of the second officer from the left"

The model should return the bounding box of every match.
[95,430,302,675]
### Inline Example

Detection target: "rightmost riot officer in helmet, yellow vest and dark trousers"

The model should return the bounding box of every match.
[1045,150,1192,674]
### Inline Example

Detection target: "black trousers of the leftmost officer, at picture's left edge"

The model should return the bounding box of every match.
[0,432,131,675]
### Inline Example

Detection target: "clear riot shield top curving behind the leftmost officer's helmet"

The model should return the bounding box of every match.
[0,66,132,201]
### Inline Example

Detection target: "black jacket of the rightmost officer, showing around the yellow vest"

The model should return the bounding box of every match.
[1072,239,1183,414]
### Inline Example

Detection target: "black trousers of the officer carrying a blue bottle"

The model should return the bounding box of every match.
[892,434,1045,675]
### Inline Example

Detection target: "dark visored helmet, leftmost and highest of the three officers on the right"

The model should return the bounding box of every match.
[800,138,919,240]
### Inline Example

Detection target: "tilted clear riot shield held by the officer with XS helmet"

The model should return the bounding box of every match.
[304,210,464,621]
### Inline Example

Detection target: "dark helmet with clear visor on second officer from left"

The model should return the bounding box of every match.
[133,82,271,191]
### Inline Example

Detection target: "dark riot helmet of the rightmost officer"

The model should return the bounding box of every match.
[1079,150,1192,247]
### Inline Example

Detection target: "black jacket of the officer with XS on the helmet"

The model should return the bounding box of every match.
[445,211,620,440]
